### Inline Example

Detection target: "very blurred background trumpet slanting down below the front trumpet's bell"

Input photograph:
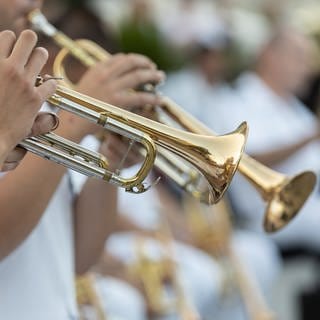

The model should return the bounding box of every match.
[183,197,276,320]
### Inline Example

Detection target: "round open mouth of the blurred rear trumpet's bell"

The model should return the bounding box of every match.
[264,171,316,233]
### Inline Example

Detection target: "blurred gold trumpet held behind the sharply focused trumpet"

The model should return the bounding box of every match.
[29,10,316,228]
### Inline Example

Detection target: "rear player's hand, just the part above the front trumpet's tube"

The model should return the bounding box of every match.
[77,53,164,108]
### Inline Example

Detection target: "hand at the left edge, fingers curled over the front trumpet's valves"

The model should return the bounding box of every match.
[0,30,56,156]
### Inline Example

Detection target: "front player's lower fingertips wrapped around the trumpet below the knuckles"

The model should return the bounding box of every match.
[1,112,59,171]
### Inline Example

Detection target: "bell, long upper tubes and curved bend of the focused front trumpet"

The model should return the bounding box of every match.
[49,82,246,204]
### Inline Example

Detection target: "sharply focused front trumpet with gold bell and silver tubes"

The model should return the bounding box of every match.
[21,79,246,199]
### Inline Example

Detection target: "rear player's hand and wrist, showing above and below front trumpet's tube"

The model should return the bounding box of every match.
[54,54,164,148]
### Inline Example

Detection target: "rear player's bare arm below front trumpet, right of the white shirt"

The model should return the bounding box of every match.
[75,179,117,274]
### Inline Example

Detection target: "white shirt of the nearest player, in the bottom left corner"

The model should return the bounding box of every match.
[0,104,77,320]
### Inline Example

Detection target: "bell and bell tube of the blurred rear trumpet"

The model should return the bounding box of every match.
[162,98,316,232]
